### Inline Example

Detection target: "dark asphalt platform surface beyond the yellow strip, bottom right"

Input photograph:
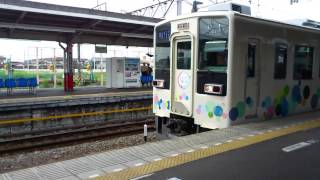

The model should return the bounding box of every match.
[144,128,320,180]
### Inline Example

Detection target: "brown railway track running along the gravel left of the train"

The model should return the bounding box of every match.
[0,118,155,154]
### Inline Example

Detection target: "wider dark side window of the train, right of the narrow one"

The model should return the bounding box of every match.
[293,46,313,80]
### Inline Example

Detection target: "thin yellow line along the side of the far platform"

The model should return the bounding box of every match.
[0,106,152,125]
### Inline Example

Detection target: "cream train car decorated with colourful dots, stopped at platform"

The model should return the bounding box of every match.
[153,4,320,136]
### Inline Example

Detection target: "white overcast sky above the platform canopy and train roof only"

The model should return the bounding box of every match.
[25,0,320,21]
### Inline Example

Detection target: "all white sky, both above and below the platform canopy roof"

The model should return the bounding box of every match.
[0,0,320,61]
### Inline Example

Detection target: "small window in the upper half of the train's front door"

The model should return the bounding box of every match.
[177,41,191,69]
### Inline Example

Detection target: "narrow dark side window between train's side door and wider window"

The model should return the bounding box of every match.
[273,44,288,79]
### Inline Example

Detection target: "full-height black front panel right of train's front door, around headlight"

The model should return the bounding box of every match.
[197,16,229,96]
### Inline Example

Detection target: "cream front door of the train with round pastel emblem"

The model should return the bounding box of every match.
[171,36,193,117]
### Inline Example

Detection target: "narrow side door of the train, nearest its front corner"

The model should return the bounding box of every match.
[244,39,260,119]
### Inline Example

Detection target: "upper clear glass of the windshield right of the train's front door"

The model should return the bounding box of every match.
[198,17,229,72]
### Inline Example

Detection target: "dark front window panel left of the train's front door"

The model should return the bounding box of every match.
[155,23,171,89]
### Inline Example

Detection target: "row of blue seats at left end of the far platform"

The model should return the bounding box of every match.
[0,78,38,94]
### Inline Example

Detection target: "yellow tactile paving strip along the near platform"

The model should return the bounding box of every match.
[96,120,320,180]
